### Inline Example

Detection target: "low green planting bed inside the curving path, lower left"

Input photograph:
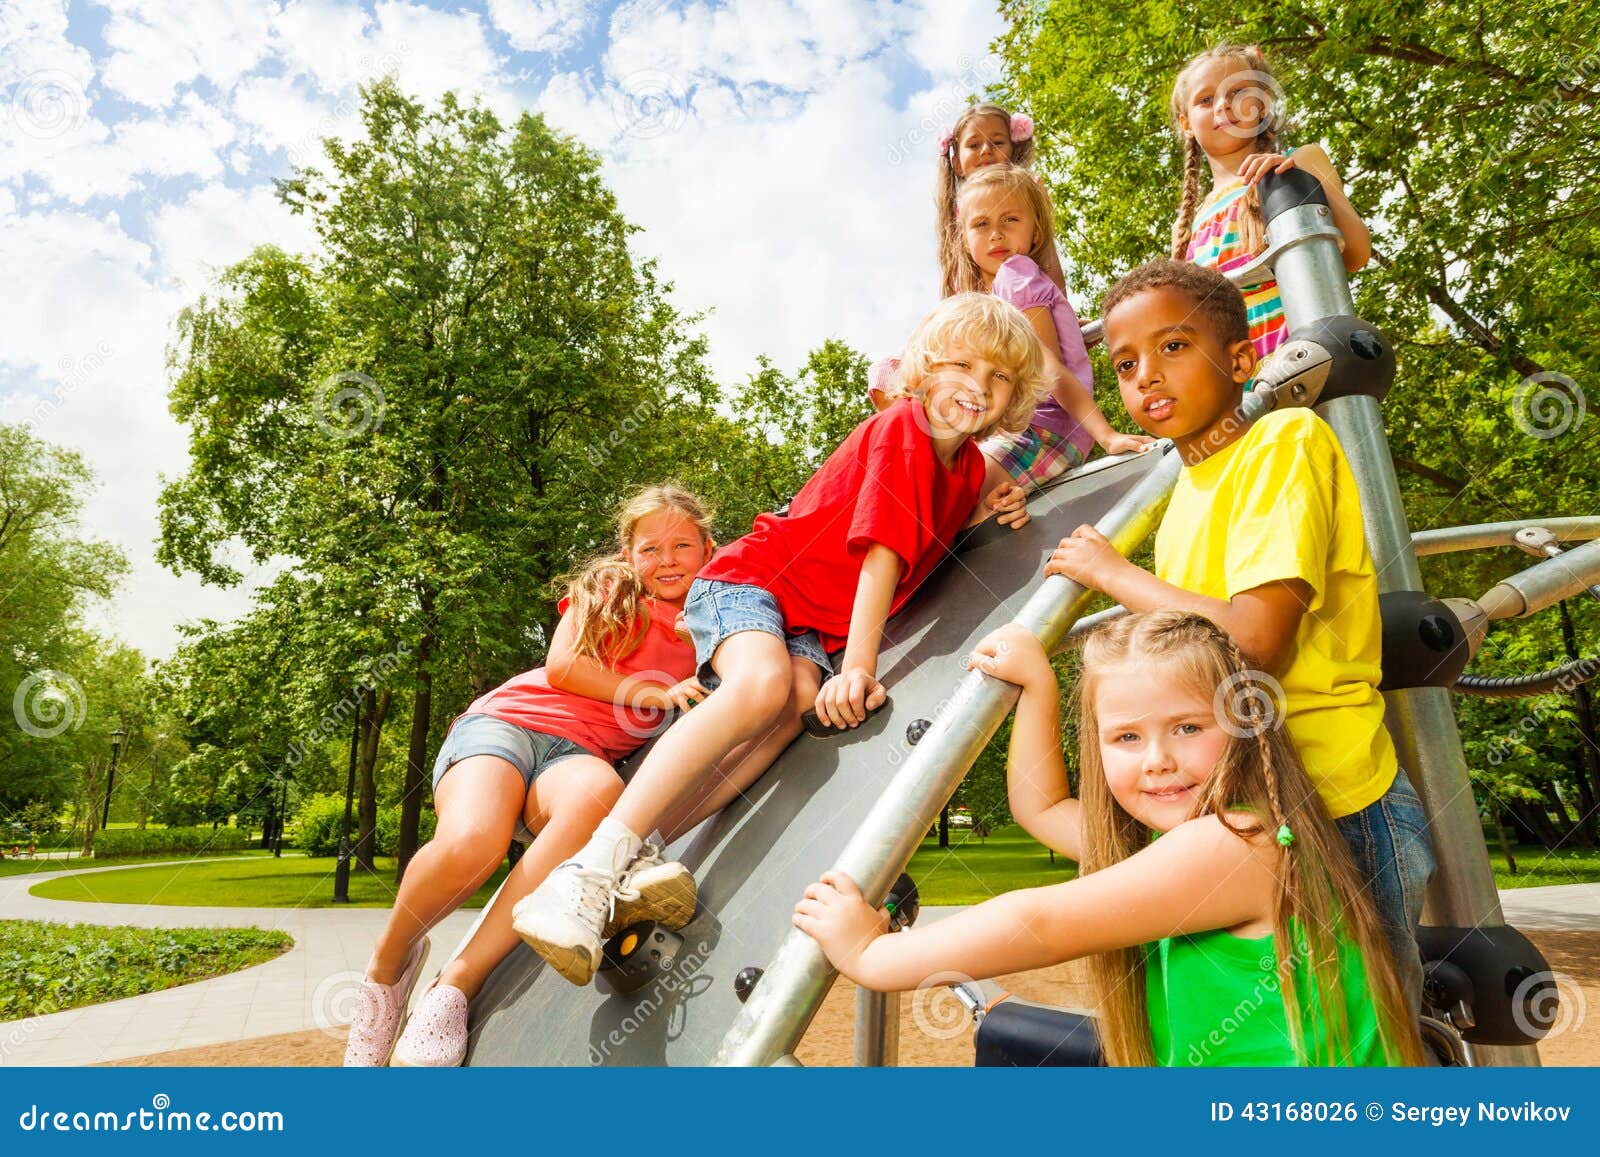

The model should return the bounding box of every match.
[0,920,294,1021]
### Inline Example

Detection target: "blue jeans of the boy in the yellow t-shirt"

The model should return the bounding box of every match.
[1333,768,1435,1008]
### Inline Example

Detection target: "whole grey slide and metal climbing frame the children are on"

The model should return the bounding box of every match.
[454,170,1600,1066]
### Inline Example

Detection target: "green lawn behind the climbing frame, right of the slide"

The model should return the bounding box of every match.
[909,826,1600,904]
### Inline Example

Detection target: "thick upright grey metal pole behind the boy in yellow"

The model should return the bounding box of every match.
[1267,180,1539,1066]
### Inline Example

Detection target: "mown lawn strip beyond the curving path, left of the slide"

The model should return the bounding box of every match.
[30,853,506,907]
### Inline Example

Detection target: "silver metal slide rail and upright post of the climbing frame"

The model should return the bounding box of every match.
[717,171,1555,1066]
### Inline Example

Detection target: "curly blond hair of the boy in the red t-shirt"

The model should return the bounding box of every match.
[883,293,1048,438]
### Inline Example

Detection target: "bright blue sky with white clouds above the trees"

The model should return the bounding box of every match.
[0,0,1003,659]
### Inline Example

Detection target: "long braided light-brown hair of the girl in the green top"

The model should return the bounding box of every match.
[1075,611,1422,1066]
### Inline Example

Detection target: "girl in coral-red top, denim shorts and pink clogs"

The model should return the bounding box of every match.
[344,486,714,1066]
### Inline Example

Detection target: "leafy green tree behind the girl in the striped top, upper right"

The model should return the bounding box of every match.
[998,0,1600,840]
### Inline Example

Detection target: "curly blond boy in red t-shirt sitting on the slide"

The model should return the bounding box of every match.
[514,293,1045,984]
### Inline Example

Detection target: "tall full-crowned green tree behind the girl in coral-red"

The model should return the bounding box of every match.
[162,82,734,871]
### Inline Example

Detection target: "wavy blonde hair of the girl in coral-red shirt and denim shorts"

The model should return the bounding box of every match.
[565,483,712,667]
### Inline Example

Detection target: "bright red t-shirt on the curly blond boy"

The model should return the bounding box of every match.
[699,398,984,651]
